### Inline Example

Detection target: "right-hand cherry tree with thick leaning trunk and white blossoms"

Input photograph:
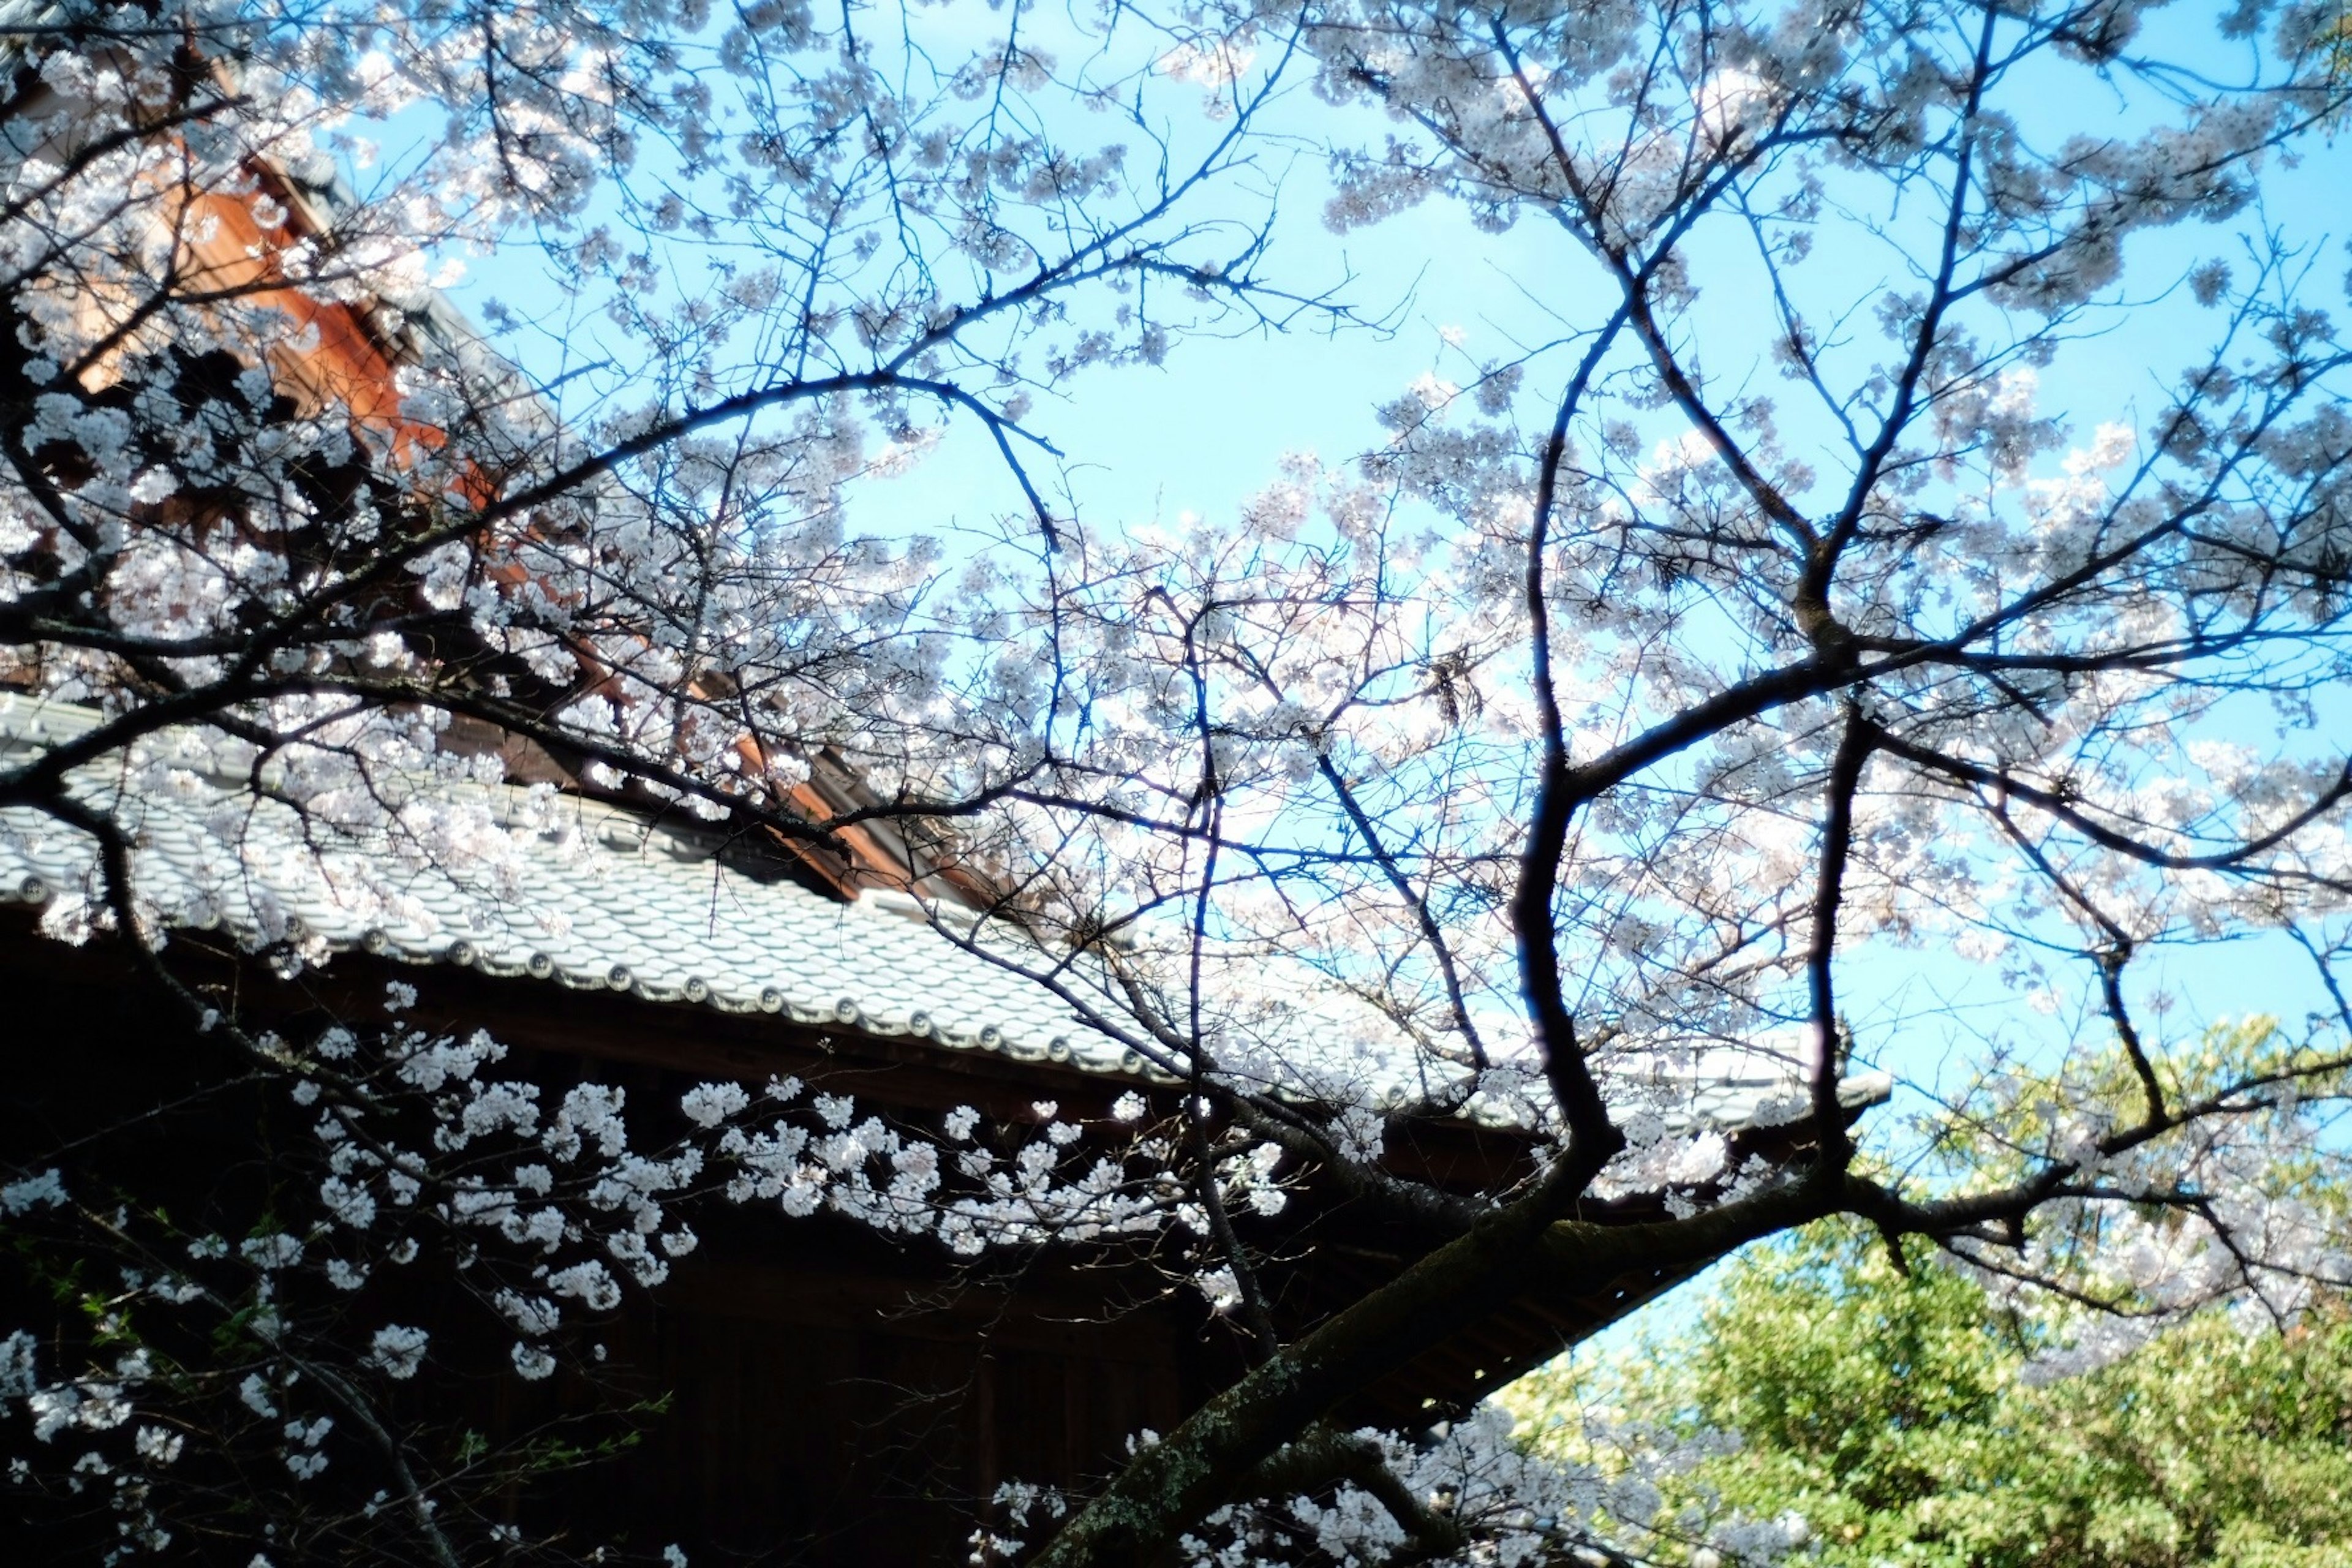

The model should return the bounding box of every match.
[912,5,2352,1563]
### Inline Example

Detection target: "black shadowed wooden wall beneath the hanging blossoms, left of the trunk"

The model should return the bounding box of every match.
[571,1237,1190,1566]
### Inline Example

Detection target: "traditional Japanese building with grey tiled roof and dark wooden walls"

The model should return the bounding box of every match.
[0,696,1884,1563]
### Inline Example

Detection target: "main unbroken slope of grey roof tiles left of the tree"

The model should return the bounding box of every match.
[0,698,1134,1072]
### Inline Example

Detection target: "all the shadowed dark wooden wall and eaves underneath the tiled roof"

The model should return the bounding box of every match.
[0,910,1703,1568]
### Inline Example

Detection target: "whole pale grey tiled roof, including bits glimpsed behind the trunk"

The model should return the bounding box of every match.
[0,696,1887,1128]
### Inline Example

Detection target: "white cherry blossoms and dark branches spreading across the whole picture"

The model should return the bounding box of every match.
[0,0,2352,1563]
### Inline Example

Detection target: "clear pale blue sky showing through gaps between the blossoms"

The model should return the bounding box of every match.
[386,17,2352,1114]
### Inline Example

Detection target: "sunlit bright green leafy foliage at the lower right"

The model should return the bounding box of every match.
[1520,1227,2352,1568]
